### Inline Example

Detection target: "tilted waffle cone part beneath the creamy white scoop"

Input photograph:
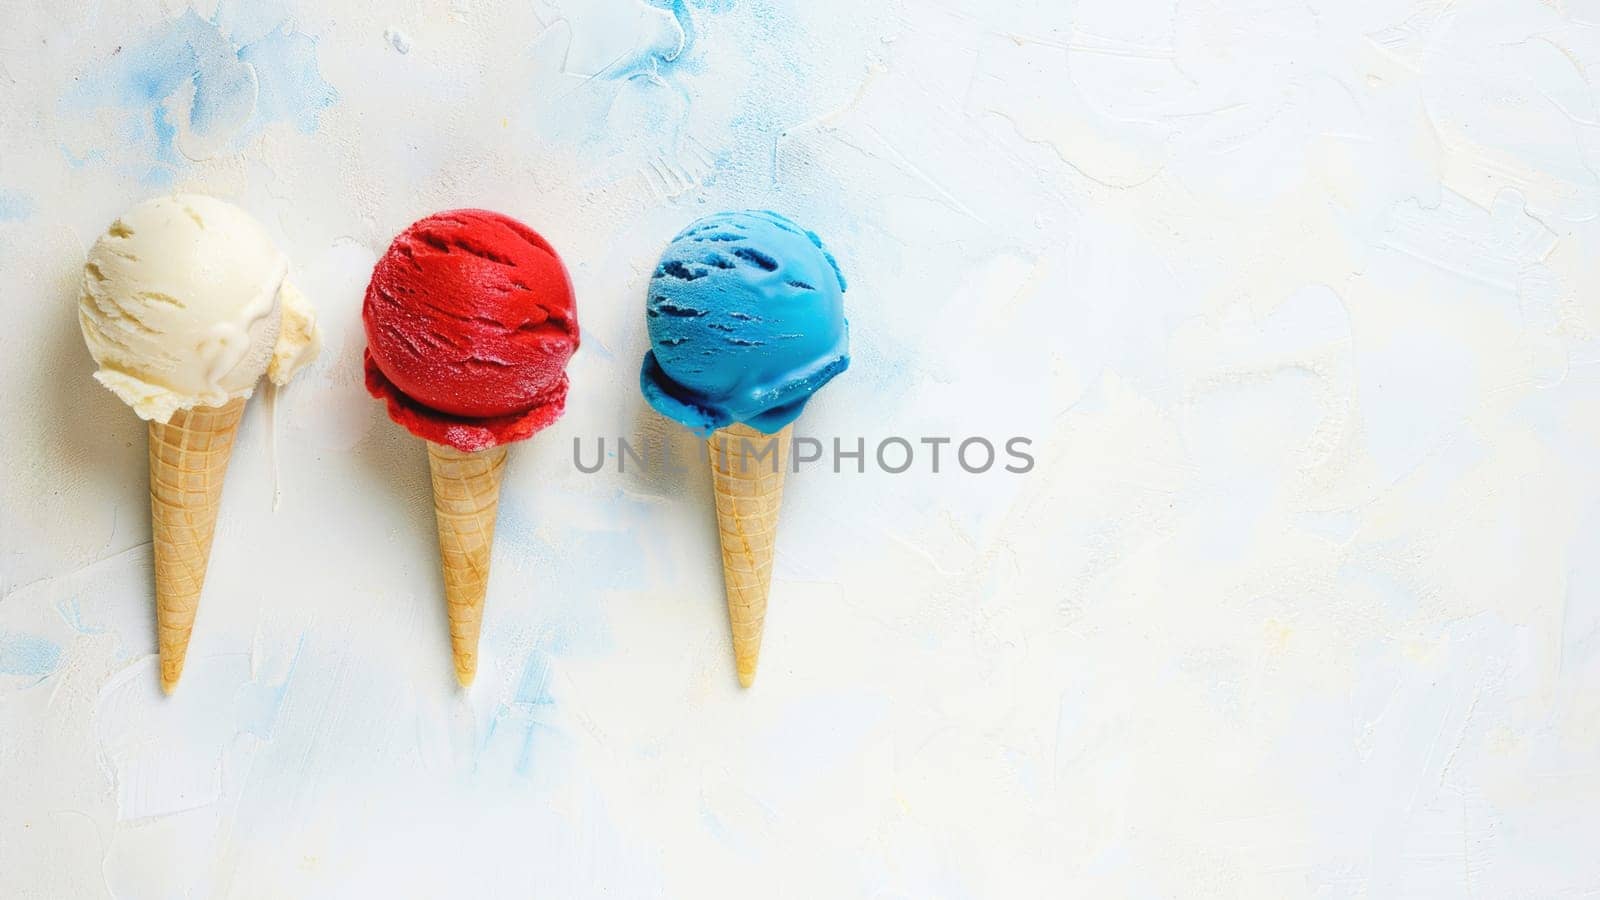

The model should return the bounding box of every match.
[150,399,245,693]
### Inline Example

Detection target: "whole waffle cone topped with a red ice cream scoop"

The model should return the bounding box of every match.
[362,210,578,687]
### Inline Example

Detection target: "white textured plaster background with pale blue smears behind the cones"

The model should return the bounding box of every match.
[0,0,1600,898]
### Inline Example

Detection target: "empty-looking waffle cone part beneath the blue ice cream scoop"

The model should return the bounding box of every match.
[707,423,790,687]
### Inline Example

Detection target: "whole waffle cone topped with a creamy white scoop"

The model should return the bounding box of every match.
[78,194,320,693]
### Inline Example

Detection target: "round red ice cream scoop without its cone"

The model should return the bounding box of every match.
[362,210,578,452]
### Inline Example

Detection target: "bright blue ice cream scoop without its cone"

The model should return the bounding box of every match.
[638,211,850,434]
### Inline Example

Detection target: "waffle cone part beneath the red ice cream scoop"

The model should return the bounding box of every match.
[427,442,506,687]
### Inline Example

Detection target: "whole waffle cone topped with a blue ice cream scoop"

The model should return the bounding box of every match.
[640,211,850,687]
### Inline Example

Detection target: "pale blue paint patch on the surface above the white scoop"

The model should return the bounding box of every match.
[64,5,338,183]
